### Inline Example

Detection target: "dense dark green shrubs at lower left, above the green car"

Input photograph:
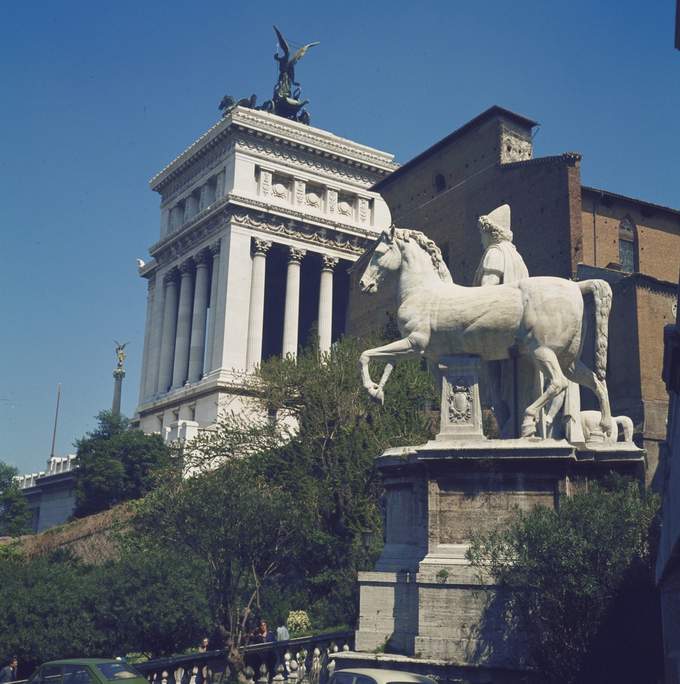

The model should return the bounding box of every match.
[0,552,209,671]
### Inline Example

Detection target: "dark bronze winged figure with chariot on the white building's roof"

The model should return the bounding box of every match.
[219,26,319,124]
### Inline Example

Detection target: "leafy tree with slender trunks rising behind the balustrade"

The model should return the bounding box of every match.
[134,459,299,669]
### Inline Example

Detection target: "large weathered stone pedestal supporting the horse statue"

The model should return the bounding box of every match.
[354,357,644,682]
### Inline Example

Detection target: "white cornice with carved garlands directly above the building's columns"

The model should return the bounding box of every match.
[149,194,378,265]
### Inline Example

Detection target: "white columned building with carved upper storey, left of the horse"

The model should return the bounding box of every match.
[137,107,396,439]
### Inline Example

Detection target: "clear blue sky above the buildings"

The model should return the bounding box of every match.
[0,0,680,472]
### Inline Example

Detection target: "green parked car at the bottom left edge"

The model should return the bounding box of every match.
[28,658,149,684]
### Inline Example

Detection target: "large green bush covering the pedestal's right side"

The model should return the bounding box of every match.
[468,478,661,684]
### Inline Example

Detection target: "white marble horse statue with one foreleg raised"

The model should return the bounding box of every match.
[358,226,614,439]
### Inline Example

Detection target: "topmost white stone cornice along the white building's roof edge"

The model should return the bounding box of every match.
[149,107,398,192]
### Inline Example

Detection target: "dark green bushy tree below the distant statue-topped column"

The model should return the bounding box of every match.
[75,411,170,517]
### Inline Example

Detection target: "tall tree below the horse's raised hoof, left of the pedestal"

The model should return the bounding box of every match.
[181,337,435,626]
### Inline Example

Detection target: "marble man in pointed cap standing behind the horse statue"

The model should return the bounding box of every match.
[472,204,541,438]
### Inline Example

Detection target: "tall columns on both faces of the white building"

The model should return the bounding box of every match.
[145,238,338,399]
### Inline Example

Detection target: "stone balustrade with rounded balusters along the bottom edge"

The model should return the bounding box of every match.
[135,632,354,684]
